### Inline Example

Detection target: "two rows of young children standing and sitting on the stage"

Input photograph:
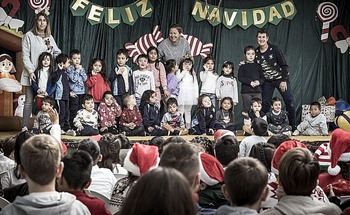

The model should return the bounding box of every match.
[32,46,328,136]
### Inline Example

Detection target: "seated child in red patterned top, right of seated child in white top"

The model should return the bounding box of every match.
[98,91,122,134]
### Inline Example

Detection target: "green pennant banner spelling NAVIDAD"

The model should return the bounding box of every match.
[192,0,297,30]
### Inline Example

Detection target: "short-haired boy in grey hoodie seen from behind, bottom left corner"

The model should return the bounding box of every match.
[1,134,90,215]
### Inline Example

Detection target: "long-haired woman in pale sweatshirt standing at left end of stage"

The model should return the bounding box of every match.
[21,12,61,130]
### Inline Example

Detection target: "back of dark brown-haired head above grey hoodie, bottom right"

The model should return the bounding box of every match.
[278,147,320,196]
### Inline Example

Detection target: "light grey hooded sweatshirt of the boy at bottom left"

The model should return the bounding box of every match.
[0,192,90,215]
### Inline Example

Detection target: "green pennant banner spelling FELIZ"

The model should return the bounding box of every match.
[70,0,153,28]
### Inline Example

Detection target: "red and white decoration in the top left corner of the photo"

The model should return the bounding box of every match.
[0,0,24,32]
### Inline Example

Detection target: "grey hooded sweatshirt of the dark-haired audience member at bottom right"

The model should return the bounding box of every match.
[261,196,341,215]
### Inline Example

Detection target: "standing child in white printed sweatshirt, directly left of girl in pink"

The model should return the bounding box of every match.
[133,54,155,106]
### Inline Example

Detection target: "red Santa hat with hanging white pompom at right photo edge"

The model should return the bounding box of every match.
[328,128,350,176]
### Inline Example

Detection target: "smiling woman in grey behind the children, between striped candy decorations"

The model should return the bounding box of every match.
[158,24,191,65]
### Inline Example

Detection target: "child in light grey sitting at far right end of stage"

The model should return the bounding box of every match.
[293,102,328,136]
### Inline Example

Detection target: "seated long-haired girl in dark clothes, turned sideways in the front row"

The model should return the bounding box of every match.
[140,90,168,136]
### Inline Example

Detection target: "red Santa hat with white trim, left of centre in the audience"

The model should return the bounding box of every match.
[124,143,159,176]
